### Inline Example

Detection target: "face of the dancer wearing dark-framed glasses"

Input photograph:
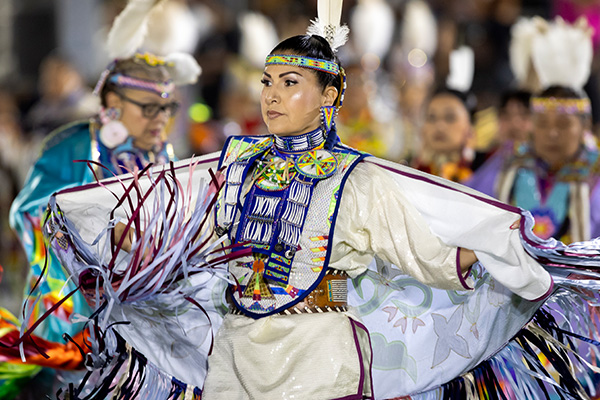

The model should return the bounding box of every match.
[106,89,174,150]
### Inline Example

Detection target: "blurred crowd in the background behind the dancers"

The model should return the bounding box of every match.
[0,0,600,312]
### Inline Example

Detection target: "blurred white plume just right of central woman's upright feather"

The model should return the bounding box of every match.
[350,0,395,58]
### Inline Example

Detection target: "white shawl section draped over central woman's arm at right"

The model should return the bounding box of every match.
[358,157,553,300]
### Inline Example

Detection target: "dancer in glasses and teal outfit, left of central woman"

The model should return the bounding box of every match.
[0,0,199,396]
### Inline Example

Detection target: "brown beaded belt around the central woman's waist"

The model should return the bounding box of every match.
[229,269,348,315]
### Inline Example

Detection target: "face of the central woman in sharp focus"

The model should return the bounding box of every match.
[260,65,337,136]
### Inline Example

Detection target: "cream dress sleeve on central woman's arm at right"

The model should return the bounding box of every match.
[330,163,465,290]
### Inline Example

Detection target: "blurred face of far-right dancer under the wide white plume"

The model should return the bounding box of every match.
[532,110,585,169]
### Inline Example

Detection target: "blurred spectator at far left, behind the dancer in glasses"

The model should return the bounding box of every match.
[25,54,100,137]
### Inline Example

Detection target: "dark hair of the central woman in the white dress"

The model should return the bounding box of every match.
[270,35,342,100]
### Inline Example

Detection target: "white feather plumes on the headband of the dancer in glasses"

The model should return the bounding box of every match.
[99,0,201,86]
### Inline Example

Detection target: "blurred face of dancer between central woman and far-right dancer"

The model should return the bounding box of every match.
[422,93,471,153]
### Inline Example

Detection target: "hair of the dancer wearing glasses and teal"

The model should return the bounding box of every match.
[100,56,170,107]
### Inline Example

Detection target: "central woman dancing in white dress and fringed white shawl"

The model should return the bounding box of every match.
[30,1,600,400]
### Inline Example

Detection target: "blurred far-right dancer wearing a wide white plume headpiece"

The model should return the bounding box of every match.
[470,18,600,243]
